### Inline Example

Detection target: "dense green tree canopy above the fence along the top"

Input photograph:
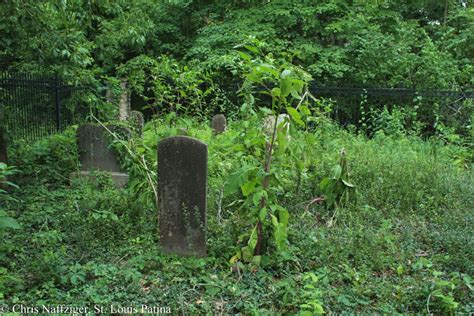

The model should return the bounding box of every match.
[0,0,474,89]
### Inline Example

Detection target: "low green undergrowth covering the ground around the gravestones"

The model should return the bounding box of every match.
[0,117,474,314]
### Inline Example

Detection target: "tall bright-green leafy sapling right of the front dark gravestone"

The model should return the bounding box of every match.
[224,39,311,266]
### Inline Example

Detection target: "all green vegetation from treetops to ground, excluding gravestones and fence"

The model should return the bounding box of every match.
[0,0,474,315]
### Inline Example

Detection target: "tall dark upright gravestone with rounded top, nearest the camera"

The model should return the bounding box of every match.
[158,136,207,256]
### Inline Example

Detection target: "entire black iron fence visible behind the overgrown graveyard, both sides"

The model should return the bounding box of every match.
[0,73,474,140]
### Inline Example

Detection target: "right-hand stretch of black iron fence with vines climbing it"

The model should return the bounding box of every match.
[310,85,474,133]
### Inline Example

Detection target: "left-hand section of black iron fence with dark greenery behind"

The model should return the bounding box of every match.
[0,73,89,141]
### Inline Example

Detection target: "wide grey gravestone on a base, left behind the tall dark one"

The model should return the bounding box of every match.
[72,124,131,187]
